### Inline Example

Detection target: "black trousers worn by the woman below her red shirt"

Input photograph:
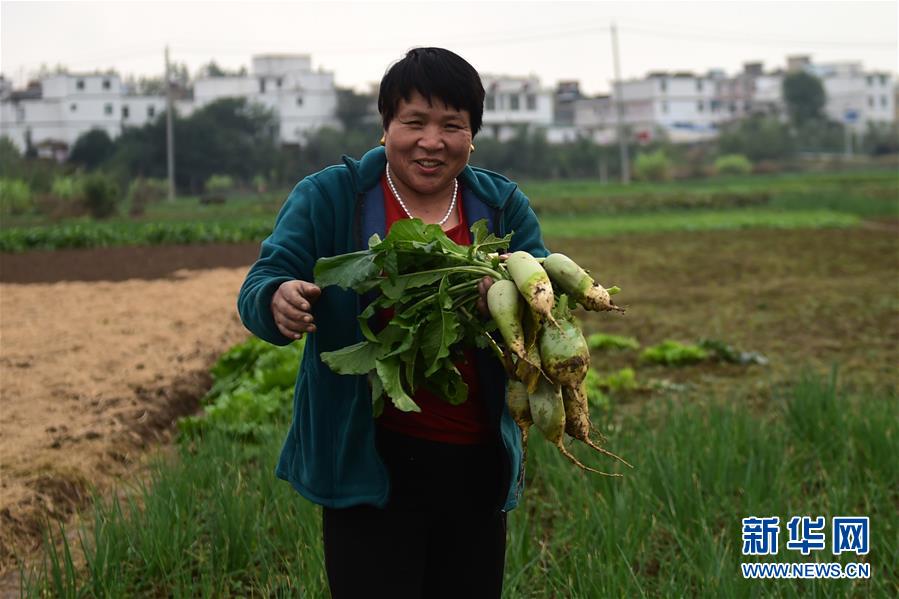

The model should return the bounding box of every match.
[322,429,506,599]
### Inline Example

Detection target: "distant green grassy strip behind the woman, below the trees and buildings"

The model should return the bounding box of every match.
[0,170,899,251]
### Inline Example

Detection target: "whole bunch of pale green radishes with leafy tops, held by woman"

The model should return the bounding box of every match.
[315,219,626,472]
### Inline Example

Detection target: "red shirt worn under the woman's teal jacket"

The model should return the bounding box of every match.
[378,176,491,444]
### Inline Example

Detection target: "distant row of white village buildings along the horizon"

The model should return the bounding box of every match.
[0,54,899,160]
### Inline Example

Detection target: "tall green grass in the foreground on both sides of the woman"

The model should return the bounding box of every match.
[24,376,899,597]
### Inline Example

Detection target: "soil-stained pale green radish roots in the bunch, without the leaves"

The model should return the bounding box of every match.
[487,252,630,476]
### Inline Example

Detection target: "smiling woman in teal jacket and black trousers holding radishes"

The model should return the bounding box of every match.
[238,48,546,598]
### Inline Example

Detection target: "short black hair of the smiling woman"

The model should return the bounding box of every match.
[378,48,484,137]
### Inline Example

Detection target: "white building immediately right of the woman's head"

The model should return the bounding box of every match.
[481,75,553,141]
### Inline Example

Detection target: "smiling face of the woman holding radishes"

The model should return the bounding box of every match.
[384,92,471,200]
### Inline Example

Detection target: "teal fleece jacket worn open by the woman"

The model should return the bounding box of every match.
[237,147,547,511]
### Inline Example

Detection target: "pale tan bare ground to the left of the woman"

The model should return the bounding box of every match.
[0,262,252,572]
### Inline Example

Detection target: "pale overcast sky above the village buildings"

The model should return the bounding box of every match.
[0,0,899,93]
